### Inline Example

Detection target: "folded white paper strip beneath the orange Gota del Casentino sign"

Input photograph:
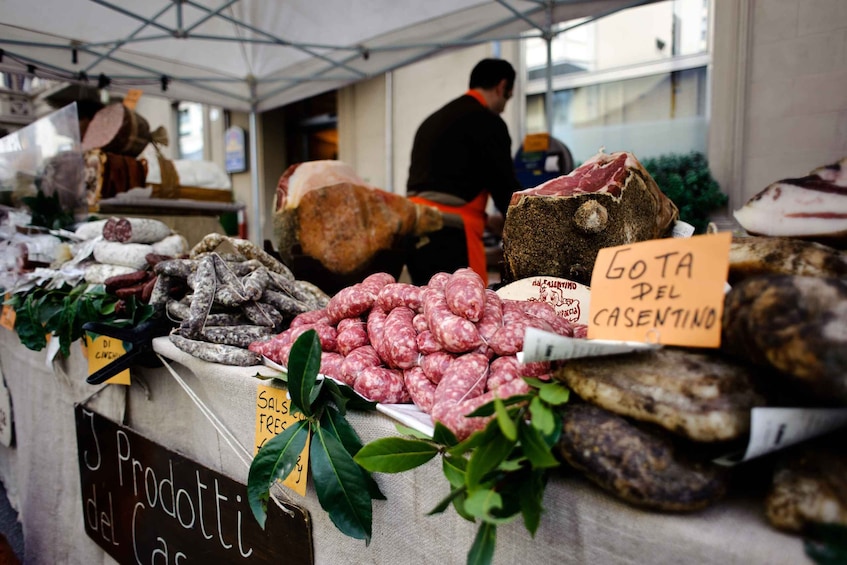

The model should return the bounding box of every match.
[517,328,662,363]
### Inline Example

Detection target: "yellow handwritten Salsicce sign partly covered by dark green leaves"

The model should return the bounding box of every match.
[253,385,309,496]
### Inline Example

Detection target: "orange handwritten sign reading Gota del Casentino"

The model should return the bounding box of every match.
[588,232,732,347]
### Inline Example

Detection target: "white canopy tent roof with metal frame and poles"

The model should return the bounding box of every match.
[0,0,655,239]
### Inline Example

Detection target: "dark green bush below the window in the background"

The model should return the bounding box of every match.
[641,151,727,233]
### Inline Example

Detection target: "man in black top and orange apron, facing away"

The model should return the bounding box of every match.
[406,59,521,285]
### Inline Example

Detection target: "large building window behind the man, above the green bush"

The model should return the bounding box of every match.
[526,0,709,163]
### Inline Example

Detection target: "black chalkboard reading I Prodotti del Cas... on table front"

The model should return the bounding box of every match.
[74,405,314,565]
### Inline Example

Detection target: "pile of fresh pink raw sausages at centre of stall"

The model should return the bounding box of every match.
[249,269,584,438]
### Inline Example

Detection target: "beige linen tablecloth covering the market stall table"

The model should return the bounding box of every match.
[0,330,810,565]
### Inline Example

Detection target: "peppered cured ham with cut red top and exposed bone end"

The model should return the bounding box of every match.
[503,152,679,285]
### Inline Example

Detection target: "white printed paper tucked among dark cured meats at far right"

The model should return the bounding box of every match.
[715,408,847,465]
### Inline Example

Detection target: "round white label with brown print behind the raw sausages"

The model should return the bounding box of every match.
[496,276,591,325]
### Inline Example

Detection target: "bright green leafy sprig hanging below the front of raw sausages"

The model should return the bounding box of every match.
[354,379,569,565]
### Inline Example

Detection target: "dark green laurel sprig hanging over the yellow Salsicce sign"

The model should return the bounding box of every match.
[247,330,385,544]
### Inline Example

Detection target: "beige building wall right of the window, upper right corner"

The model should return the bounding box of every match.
[709,0,847,209]
